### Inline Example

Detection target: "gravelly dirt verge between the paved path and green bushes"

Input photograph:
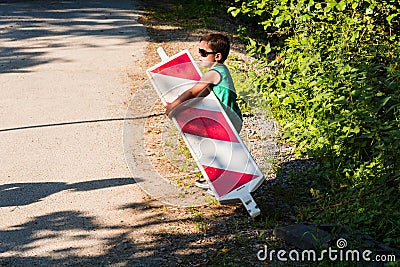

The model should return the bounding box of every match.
[123,1,400,266]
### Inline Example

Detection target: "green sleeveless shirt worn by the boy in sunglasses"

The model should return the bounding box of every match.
[211,64,243,132]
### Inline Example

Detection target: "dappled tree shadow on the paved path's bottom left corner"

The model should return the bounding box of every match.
[0,211,148,266]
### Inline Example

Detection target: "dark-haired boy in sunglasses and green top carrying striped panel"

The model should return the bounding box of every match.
[166,33,243,189]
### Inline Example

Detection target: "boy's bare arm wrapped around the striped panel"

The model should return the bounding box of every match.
[165,71,220,116]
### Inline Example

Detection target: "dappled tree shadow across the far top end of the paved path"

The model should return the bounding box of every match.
[0,0,145,73]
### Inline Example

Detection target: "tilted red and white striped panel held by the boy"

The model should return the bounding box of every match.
[147,50,263,218]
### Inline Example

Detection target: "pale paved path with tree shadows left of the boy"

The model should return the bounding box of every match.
[0,0,158,266]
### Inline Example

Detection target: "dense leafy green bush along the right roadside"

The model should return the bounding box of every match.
[229,0,400,245]
